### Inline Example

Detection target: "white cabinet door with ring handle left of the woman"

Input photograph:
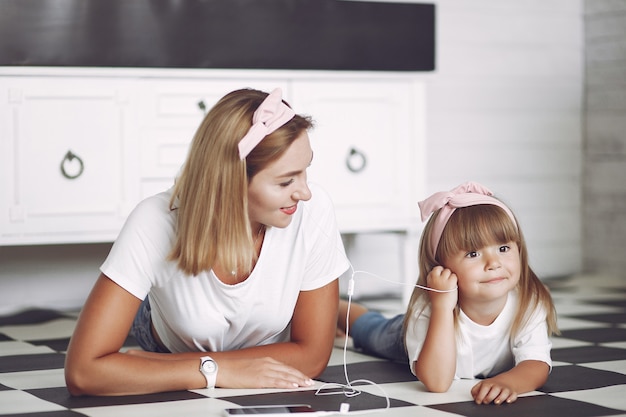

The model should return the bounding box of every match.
[0,77,138,244]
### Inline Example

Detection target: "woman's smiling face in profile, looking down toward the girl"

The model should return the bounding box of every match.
[248,132,313,230]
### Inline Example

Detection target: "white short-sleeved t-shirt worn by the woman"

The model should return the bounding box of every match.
[100,184,349,353]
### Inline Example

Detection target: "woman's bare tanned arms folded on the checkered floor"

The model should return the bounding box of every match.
[65,275,338,395]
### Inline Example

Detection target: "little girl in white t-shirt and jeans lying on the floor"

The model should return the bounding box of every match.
[340,182,558,404]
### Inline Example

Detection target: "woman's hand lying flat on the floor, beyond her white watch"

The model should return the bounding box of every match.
[217,357,314,389]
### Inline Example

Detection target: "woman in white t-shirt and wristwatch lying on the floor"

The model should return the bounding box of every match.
[65,89,348,395]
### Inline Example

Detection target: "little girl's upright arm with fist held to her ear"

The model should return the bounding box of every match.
[415,266,458,392]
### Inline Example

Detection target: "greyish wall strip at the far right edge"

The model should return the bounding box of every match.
[583,0,626,279]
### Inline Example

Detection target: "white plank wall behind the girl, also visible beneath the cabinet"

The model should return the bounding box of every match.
[0,0,583,308]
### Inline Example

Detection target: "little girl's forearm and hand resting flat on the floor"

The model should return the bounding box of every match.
[471,360,550,404]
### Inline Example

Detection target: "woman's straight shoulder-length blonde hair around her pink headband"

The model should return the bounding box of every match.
[169,89,313,275]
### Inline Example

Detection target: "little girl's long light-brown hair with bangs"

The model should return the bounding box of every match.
[404,204,559,337]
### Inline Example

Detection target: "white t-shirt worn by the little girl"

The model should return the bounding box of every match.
[406,291,552,379]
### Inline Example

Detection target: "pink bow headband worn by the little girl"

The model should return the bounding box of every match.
[418,182,517,258]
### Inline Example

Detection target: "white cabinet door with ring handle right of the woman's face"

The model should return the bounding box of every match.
[292,80,418,232]
